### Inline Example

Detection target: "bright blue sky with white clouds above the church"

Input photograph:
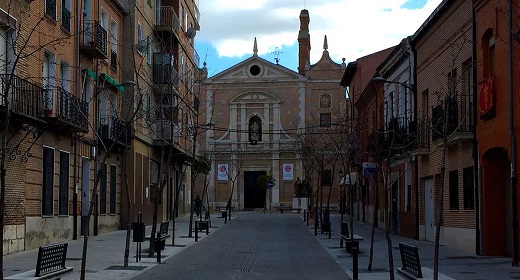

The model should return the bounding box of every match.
[195,0,441,76]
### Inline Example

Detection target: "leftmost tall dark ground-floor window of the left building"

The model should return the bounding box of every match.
[42,147,54,216]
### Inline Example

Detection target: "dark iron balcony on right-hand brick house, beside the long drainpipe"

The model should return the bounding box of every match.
[432,95,475,145]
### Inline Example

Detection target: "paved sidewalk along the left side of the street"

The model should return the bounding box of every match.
[4,213,230,280]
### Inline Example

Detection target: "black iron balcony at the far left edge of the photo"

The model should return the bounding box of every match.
[0,74,45,124]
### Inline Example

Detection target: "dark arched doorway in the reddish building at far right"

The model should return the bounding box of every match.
[482,147,513,256]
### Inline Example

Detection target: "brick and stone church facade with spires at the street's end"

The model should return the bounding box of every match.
[194,10,346,210]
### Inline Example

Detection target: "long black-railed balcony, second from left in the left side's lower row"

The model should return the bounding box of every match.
[43,87,88,132]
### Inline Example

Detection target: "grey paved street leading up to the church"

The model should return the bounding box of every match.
[134,212,347,280]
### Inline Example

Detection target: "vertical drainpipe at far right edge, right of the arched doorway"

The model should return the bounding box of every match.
[507,0,518,265]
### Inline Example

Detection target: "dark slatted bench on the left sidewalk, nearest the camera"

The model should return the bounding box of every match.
[4,243,74,280]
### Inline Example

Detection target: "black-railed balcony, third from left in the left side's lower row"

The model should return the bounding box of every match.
[99,116,131,150]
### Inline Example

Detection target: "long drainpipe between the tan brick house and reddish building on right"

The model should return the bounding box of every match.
[471,2,482,255]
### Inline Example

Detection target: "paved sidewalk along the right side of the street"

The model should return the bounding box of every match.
[309,214,520,280]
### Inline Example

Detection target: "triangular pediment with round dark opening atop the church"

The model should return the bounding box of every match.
[208,56,306,82]
